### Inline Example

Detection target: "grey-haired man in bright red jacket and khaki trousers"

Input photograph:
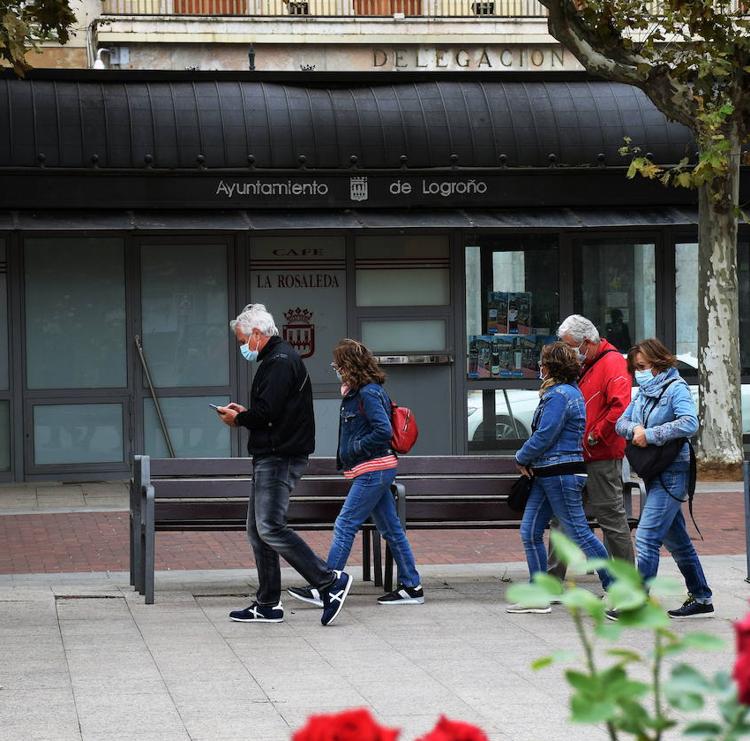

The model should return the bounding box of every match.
[547,314,634,579]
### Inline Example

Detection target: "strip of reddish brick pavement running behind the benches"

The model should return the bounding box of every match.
[0,491,745,574]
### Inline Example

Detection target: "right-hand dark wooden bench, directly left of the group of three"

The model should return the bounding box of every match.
[384,455,642,589]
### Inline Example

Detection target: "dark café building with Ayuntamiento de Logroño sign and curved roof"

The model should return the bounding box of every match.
[0,70,750,480]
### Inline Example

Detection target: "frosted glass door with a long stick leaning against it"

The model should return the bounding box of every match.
[136,238,237,458]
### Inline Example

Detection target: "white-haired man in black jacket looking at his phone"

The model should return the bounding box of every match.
[217,304,352,625]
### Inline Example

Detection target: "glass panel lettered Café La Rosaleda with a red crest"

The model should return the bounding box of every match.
[249,237,347,384]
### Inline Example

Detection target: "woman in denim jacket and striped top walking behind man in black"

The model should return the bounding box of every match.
[288,339,424,606]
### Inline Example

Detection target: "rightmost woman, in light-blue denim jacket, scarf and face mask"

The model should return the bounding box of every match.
[608,338,714,618]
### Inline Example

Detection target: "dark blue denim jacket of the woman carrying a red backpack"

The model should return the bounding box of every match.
[336,383,393,469]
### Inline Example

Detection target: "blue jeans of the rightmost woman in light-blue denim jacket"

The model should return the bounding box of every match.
[635,469,711,604]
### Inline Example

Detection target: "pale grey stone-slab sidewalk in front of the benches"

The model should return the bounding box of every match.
[0,556,750,741]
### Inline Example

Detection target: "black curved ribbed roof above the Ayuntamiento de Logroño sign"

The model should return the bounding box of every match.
[0,71,694,171]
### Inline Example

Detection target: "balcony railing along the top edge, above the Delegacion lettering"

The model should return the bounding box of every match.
[103,0,748,18]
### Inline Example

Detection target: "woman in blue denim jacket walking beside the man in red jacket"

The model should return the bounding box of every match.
[506,342,611,613]
